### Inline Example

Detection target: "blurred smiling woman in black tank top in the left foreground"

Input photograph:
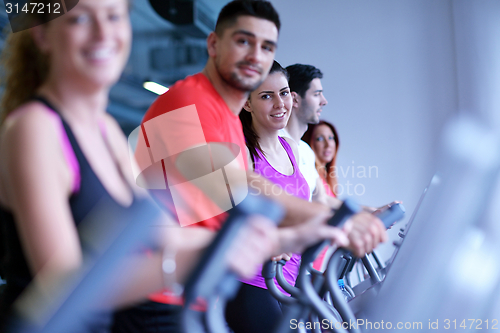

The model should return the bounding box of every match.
[0,0,276,327]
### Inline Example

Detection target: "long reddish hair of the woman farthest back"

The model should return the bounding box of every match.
[302,120,340,195]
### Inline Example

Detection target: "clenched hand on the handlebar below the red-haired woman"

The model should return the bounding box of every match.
[343,212,388,258]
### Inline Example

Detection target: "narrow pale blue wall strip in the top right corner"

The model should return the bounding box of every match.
[453,0,500,130]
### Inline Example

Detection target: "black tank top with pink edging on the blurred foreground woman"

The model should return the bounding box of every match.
[0,97,150,329]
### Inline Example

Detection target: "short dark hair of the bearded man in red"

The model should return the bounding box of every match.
[215,0,281,36]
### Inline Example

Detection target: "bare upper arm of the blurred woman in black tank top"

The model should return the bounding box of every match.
[0,103,82,274]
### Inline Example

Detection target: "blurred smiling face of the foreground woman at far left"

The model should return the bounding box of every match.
[39,0,132,86]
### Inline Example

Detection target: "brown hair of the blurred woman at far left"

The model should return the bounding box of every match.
[0,29,49,123]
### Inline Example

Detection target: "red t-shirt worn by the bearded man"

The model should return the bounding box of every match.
[142,73,247,304]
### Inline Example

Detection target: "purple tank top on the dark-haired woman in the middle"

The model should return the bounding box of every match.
[240,137,309,295]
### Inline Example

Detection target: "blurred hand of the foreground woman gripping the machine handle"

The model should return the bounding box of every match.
[226,216,279,278]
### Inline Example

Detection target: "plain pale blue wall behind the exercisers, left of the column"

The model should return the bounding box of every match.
[272,0,458,252]
